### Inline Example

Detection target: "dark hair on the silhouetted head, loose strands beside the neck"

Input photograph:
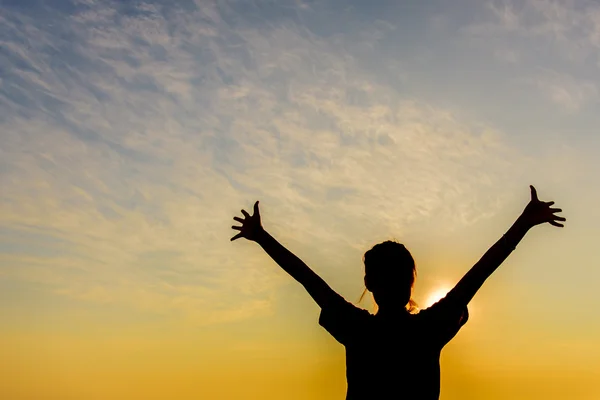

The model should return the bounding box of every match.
[359,240,418,312]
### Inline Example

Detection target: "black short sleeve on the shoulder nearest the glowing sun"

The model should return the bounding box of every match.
[419,296,469,347]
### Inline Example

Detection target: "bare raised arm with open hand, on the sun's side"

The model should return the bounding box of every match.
[446,186,565,305]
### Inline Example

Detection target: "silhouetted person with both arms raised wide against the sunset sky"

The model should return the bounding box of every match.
[231,186,565,400]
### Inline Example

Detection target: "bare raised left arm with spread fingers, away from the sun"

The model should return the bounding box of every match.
[231,201,343,308]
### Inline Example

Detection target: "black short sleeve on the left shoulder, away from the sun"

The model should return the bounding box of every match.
[319,296,371,346]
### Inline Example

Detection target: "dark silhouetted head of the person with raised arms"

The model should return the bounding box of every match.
[363,240,417,310]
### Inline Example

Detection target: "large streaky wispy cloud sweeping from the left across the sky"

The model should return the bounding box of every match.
[0,1,528,323]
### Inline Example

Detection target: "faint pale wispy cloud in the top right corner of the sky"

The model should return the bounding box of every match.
[463,0,600,114]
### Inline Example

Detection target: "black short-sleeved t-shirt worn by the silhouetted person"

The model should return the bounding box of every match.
[319,296,469,400]
